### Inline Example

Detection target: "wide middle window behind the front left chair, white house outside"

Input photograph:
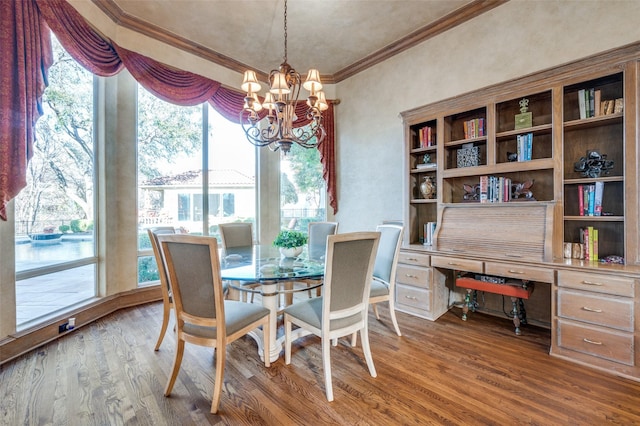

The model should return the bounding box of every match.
[138,93,256,284]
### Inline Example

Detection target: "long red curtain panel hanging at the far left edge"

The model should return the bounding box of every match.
[0,1,53,220]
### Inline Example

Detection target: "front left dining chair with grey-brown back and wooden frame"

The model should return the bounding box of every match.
[158,235,271,413]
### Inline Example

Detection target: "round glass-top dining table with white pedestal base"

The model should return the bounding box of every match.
[220,245,324,362]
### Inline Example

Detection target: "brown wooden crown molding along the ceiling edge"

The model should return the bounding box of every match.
[92,0,509,84]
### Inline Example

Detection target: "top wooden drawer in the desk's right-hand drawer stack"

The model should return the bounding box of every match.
[558,271,635,297]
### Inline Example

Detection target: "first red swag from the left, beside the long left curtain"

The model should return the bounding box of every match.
[35,0,123,77]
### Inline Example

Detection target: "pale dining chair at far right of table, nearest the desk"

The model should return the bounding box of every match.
[369,224,404,336]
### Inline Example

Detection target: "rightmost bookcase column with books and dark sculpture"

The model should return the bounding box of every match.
[563,73,626,263]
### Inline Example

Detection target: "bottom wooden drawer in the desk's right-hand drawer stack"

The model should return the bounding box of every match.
[558,320,634,365]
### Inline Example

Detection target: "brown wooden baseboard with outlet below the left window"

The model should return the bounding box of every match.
[0,286,162,365]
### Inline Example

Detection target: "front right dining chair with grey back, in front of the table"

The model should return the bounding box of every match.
[284,232,380,401]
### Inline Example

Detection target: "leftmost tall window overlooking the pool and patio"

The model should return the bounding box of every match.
[15,37,97,328]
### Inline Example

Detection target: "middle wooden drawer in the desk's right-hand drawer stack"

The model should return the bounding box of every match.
[558,288,633,331]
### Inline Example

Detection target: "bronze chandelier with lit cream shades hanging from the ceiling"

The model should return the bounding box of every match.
[240,0,329,154]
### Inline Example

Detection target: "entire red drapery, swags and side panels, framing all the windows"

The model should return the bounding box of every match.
[0,0,337,220]
